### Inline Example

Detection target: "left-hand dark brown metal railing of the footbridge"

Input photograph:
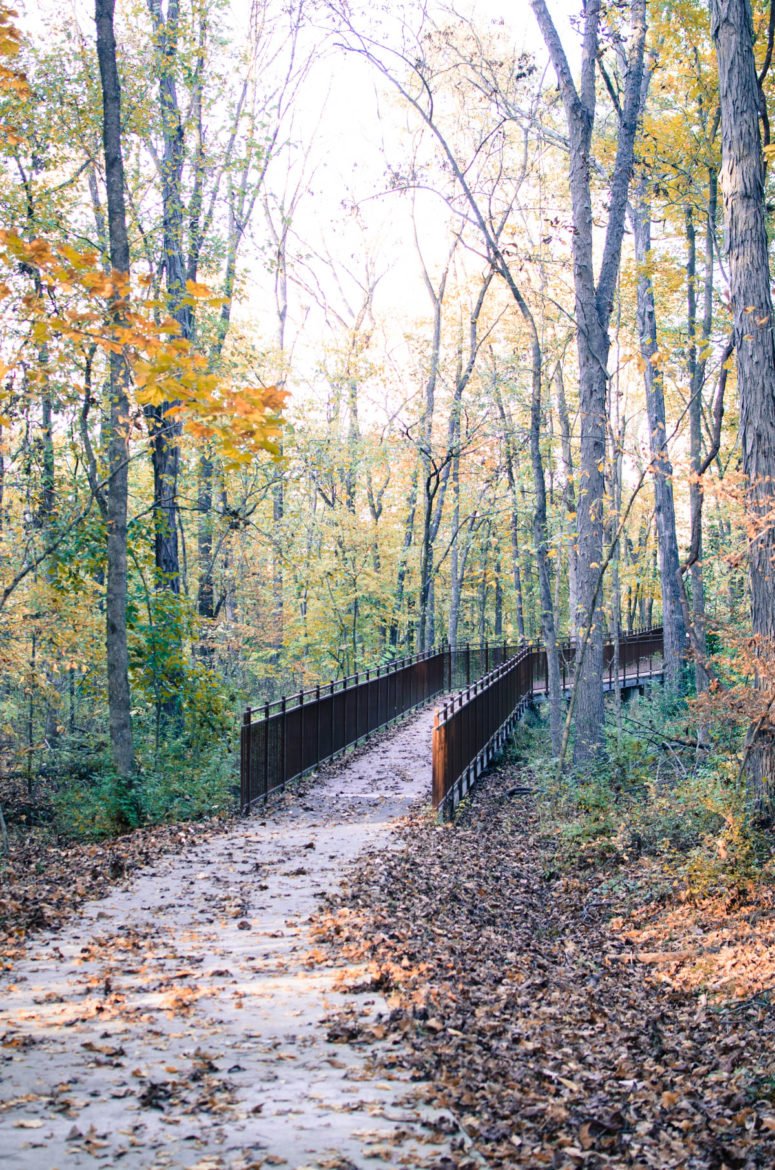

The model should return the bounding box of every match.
[240,642,519,812]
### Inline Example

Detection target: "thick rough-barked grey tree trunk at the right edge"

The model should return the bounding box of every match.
[711,0,775,821]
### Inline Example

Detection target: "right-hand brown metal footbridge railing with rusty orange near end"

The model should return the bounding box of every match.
[432,628,663,814]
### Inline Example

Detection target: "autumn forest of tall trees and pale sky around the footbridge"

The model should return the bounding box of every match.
[0,0,775,879]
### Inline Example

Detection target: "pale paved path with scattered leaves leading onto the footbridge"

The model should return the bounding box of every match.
[0,710,456,1170]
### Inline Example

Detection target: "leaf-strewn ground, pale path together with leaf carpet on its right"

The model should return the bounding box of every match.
[0,711,775,1170]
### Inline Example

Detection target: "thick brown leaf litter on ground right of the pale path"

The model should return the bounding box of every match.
[317,769,775,1170]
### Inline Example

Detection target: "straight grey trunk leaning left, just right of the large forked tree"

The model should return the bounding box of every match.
[630,187,686,693]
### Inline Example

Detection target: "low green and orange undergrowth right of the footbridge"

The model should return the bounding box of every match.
[507,688,775,897]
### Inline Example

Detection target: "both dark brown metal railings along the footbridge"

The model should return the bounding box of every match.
[240,627,663,815]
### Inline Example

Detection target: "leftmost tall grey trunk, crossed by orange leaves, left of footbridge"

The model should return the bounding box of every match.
[95,0,133,777]
